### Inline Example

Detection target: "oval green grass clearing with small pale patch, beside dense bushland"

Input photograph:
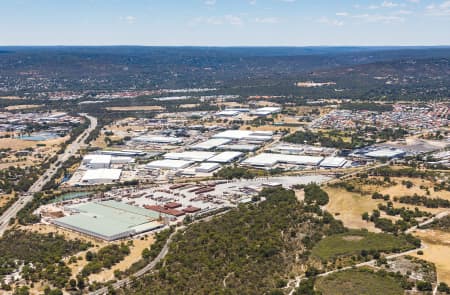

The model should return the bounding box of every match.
[312,230,414,260]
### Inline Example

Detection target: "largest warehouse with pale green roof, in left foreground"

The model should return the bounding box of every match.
[52,201,163,241]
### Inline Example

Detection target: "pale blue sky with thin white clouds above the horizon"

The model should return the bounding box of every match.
[0,0,450,46]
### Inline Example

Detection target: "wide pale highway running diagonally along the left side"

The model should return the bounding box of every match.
[0,114,97,237]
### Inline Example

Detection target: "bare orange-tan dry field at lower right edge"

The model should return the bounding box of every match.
[413,230,450,284]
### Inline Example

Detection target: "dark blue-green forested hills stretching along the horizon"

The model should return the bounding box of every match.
[0,46,450,98]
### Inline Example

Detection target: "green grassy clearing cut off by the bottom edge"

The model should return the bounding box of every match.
[315,270,404,295]
